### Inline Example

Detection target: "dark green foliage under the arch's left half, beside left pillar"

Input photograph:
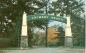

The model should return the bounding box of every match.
[28,18,48,46]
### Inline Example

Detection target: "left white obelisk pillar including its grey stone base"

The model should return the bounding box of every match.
[20,12,28,48]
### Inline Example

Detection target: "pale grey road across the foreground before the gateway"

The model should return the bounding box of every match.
[0,47,85,53]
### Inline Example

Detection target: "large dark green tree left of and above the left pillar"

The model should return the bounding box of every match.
[0,0,44,46]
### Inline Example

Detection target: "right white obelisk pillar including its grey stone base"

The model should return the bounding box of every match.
[65,16,73,47]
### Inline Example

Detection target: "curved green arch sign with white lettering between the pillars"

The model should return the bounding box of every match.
[27,15,67,23]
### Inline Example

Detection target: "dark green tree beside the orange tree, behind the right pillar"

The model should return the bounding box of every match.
[51,25,65,46]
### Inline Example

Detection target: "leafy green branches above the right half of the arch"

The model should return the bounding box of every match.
[50,0,84,16]
